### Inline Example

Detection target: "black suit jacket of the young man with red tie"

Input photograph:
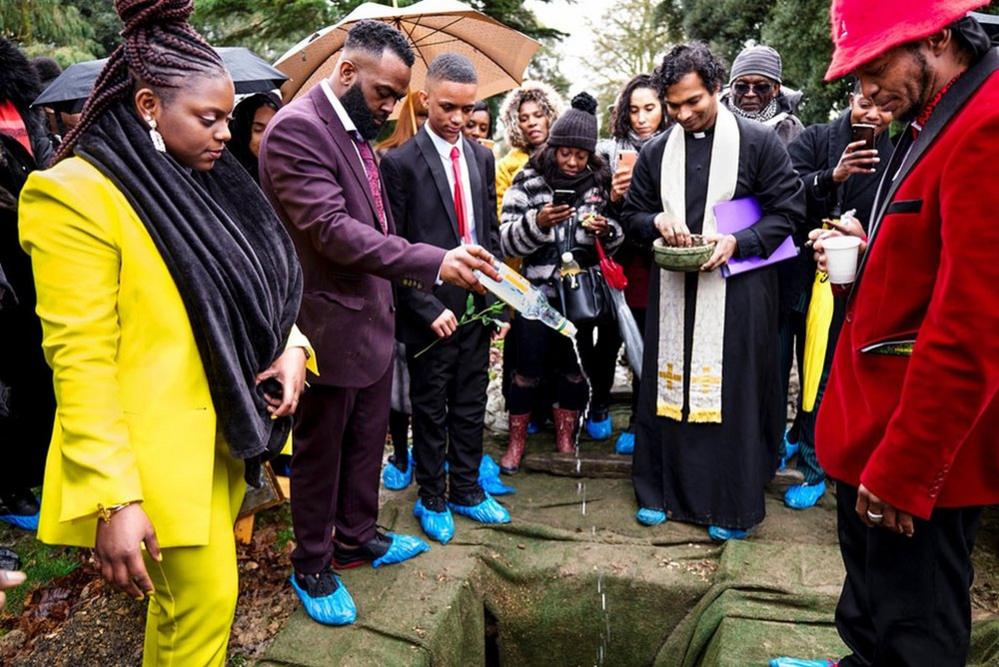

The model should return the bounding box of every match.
[380,129,499,346]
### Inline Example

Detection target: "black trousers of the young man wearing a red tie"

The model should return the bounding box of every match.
[406,323,491,504]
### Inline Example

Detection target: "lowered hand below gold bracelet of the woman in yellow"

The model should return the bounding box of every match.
[94,503,162,600]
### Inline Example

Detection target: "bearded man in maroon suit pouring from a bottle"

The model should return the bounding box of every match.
[260,21,498,625]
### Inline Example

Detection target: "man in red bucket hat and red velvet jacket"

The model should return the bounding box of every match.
[771,0,999,667]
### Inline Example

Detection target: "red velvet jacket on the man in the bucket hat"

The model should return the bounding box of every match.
[816,64,999,519]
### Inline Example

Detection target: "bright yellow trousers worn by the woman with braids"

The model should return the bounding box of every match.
[142,445,246,667]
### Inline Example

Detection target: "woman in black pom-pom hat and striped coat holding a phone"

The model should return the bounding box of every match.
[500,93,624,474]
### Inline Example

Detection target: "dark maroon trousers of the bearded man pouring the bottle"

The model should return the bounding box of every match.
[291,364,392,574]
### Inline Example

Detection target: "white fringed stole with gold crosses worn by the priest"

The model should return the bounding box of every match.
[656,104,739,423]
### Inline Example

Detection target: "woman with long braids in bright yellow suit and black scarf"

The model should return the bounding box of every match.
[19,0,310,665]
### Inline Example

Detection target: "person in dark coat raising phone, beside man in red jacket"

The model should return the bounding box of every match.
[782,84,893,509]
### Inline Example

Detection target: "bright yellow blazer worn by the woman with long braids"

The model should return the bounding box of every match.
[19,158,314,547]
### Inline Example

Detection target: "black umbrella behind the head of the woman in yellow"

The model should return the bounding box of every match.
[32,46,288,113]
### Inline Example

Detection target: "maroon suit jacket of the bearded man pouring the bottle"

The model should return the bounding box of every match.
[260,86,445,387]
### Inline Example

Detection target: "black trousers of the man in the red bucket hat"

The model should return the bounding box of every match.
[836,482,982,667]
